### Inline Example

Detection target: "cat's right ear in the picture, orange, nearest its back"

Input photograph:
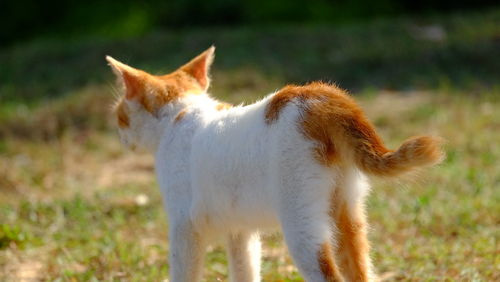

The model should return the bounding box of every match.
[180,46,215,90]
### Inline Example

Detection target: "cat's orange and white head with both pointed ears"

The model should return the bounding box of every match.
[106,46,215,150]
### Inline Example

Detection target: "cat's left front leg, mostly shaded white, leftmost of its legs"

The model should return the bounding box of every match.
[169,219,205,282]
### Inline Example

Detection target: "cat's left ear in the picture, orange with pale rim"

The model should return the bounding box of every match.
[106,56,144,99]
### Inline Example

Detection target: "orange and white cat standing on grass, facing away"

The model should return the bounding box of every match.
[106,46,443,282]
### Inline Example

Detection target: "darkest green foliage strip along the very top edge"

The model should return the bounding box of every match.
[0,0,498,46]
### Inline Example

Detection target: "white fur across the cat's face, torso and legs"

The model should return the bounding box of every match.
[121,91,374,281]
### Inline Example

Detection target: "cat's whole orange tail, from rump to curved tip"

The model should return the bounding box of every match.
[344,117,444,177]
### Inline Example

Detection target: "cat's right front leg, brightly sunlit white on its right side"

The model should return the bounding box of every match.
[227,232,261,282]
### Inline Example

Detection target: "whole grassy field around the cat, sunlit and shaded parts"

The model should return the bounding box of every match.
[0,9,500,281]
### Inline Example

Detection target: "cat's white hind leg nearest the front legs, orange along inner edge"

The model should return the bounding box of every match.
[280,173,343,282]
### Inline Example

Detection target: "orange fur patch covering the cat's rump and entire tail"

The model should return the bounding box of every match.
[265,82,442,176]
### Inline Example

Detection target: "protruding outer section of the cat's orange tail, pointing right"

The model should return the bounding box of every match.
[357,136,444,177]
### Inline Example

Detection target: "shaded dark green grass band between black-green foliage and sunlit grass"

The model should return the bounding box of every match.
[0,8,500,106]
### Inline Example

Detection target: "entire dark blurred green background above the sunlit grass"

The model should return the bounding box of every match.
[0,0,499,102]
